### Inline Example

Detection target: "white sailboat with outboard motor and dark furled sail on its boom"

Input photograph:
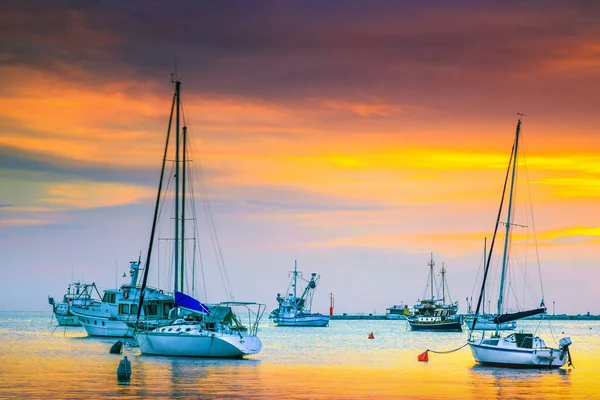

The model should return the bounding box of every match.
[468,118,571,368]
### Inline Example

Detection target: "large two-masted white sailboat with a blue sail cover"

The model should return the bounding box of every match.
[134,80,265,358]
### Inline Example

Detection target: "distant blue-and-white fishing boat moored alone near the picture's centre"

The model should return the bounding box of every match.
[269,261,329,327]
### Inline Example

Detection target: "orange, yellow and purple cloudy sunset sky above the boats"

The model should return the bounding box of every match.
[0,0,600,314]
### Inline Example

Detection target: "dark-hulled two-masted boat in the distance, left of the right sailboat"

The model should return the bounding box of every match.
[407,253,463,332]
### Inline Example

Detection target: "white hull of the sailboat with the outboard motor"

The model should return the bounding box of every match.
[469,338,567,368]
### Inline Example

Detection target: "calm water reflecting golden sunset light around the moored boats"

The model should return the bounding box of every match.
[0,312,600,400]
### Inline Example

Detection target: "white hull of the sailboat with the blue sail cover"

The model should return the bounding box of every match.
[135,331,262,358]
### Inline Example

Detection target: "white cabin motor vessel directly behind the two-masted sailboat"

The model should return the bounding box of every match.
[71,259,173,337]
